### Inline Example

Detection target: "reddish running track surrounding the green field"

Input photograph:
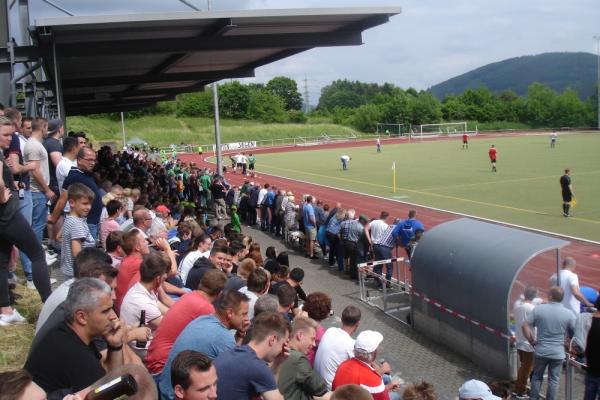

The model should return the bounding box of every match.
[179,133,600,299]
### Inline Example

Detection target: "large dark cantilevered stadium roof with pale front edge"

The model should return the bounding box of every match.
[32,7,400,115]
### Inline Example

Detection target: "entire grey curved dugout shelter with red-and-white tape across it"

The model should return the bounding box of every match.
[411,218,569,379]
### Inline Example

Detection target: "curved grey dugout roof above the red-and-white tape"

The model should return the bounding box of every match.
[411,218,569,331]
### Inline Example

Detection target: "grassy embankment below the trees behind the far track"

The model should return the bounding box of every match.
[67,115,359,147]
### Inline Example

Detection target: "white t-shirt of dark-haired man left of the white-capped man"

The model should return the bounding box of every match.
[314,327,354,390]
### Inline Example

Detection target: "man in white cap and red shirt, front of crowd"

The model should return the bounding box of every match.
[331,330,400,400]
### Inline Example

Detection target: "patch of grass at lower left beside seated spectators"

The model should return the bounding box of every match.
[0,285,42,372]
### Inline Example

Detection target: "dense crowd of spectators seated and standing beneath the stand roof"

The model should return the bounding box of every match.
[0,104,597,400]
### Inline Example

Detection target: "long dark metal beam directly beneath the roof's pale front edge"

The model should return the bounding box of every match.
[57,31,362,57]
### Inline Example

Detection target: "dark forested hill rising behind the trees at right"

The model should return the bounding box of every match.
[430,53,597,100]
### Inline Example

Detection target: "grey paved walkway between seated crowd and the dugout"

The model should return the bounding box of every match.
[243,226,583,400]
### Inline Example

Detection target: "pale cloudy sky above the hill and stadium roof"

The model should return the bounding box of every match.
[24,0,600,105]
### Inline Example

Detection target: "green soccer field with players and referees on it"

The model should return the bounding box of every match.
[257,133,600,241]
